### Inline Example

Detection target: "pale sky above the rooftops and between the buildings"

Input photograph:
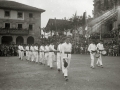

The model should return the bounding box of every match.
[6,0,93,28]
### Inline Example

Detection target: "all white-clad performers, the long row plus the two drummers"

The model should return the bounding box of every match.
[18,37,106,81]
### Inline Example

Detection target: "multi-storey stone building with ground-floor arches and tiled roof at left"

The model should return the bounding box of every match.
[0,1,45,44]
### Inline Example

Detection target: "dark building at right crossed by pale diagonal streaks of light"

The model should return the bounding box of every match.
[89,0,120,43]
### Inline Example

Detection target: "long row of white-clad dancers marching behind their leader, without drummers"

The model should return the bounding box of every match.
[18,37,72,81]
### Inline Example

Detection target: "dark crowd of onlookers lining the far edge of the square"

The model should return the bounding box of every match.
[0,37,120,56]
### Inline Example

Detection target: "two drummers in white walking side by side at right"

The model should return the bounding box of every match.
[88,40,107,69]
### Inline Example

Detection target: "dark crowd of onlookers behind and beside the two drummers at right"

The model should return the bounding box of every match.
[72,40,120,56]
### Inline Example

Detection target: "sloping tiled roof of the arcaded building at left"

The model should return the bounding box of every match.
[0,1,45,12]
